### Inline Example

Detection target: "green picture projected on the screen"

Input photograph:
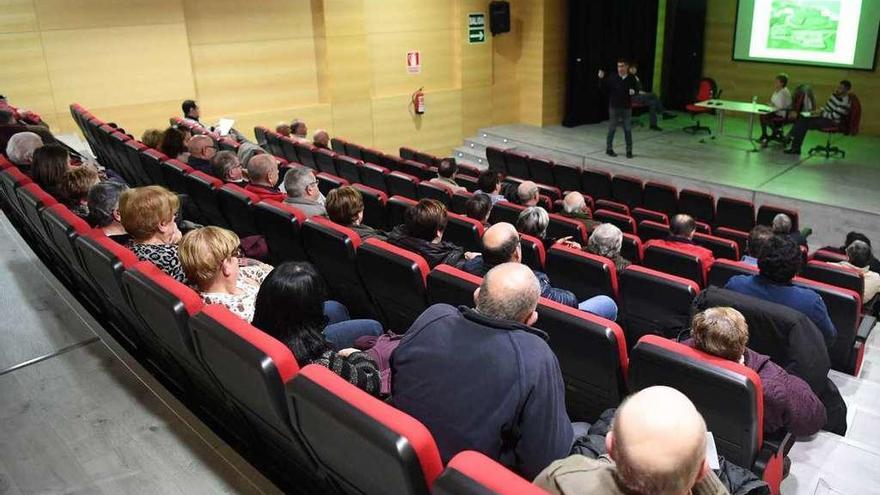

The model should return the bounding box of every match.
[767,0,840,53]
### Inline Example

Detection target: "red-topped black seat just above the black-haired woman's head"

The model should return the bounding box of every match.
[254,200,308,266]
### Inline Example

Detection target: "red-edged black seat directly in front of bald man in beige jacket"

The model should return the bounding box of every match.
[629,336,793,494]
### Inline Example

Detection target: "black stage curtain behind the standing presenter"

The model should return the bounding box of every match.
[562,0,658,127]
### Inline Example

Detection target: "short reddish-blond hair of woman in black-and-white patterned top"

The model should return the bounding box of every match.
[119,186,180,244]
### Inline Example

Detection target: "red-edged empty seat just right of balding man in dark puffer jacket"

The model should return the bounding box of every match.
[547,245,620,301]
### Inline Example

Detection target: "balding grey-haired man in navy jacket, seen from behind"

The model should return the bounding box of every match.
[391,263,574,479]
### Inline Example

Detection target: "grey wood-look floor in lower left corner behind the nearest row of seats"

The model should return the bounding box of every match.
[0,214,280,495]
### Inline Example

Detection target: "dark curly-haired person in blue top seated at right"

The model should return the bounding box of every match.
[724,235,837,347]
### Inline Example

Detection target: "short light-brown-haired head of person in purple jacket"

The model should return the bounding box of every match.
[691,307,749,362]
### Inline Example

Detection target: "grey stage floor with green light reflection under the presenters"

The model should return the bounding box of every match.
[454,115,880,248]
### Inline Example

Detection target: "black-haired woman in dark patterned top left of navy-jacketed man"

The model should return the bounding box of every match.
[253,262,382,395]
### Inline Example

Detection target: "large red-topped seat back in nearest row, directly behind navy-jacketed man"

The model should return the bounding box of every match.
[287,365,443,495]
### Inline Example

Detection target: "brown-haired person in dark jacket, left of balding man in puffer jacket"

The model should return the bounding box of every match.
[388,199,475,269]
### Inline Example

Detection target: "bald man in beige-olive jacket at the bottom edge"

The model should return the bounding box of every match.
[535,386,728,495]
